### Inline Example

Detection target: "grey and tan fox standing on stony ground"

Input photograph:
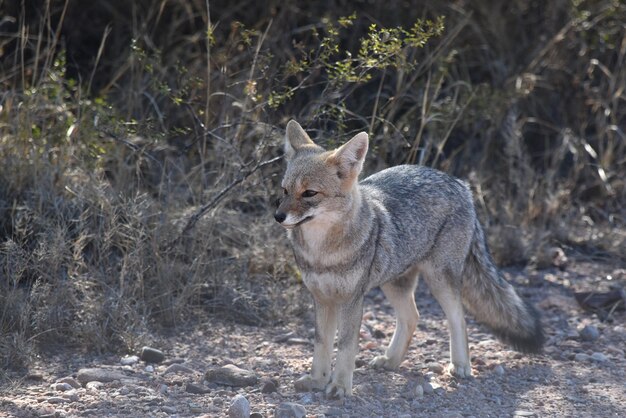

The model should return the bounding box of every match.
[274,120,544,398]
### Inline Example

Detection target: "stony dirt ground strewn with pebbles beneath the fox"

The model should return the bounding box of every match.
[0,260,626,418]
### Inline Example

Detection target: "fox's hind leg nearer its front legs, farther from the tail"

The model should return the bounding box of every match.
[370,272,419,370]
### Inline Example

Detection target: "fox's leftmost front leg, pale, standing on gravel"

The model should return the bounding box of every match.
[295,301,337,392]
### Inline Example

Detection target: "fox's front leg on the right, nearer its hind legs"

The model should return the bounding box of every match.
[326,299,363,399]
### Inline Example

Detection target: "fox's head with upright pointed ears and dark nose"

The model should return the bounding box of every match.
[274,120,368,229]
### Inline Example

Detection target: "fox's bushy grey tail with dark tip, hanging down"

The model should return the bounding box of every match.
[462,220,544,353]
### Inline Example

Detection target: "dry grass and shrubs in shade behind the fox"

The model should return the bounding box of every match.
[0,0,626,374]
